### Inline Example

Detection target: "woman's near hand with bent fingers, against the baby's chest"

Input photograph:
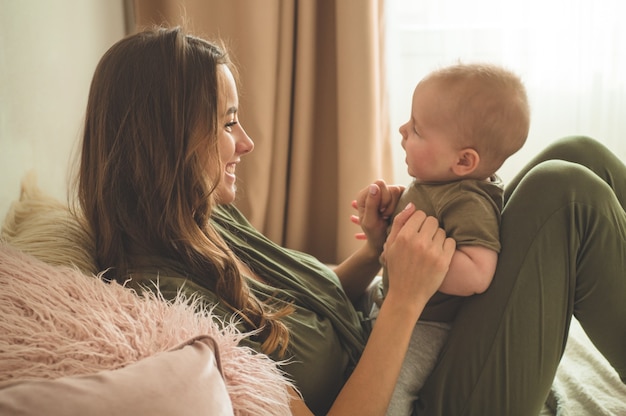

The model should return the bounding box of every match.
[381,204,456,314]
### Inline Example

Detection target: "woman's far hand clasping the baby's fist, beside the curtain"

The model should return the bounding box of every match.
[351,179,404,252]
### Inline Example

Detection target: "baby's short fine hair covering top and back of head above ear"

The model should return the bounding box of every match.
[420,63,530,176]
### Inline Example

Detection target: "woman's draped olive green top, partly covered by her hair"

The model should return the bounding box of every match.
[131,205,368,414]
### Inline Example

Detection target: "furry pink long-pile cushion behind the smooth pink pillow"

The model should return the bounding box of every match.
[0,243,292,415]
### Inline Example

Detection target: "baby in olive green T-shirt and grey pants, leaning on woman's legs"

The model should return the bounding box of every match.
[372,64,530,415]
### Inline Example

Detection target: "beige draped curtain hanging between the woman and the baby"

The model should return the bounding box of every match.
[134,0,391,262]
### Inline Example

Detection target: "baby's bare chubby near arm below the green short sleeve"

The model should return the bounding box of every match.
[439,245,498,296]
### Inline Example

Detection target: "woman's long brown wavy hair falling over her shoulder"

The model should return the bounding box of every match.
[77,28,289,354]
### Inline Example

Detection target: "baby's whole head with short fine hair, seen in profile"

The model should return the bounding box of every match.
[400,64,530,181]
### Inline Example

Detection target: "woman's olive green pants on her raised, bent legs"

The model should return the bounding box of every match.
[415,137,626,416]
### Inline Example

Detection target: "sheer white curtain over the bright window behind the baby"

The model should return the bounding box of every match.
[386,0,626,183]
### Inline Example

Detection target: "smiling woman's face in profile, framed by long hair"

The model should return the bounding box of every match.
[216,65,254,204]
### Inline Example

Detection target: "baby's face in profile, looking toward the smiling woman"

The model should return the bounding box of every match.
[400,82,458,182]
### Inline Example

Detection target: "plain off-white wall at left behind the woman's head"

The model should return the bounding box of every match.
[0,0,124,220]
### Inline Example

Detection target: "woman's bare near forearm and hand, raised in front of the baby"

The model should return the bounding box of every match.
[292,205,455,415]
